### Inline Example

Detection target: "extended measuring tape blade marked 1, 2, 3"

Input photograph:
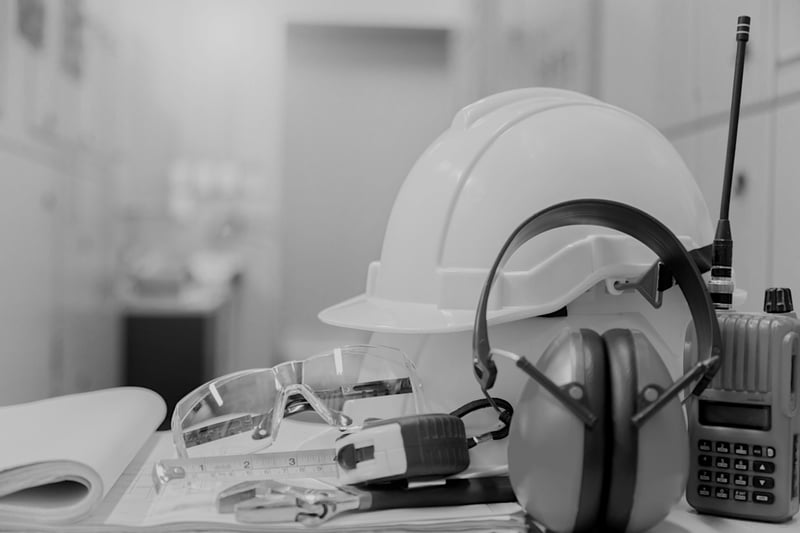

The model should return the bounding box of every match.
[153,448,338,491]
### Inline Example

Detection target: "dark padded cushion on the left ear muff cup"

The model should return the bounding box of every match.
[574,329,612,532]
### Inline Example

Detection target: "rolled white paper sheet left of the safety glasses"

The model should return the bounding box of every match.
[0,387,166,522]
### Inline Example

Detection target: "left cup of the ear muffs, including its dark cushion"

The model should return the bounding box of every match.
[508,329,611,531]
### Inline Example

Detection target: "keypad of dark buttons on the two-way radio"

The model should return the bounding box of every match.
[697,439,775,505]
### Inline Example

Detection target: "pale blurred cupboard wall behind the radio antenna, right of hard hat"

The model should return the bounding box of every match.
[598,0,800,310]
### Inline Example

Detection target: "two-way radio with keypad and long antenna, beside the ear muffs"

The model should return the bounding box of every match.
[684,17,800,522]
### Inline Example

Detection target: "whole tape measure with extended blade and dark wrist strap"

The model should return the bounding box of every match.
[153,398,513,491]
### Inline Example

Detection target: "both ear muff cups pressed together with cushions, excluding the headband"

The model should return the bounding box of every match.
[508,329,688,533]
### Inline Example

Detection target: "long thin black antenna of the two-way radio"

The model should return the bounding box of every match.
[709,16,750,309]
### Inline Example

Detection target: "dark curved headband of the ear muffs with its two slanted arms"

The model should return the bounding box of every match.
[472,199,721,424]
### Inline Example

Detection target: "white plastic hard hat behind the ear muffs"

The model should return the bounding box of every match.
[319,88,713,333]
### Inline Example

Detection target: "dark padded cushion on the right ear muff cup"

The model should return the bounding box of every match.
[603,329,639,531]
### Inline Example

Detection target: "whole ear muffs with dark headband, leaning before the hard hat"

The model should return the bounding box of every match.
[473,200,720,533]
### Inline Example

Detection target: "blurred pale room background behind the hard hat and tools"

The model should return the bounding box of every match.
[0,0,800,405]
